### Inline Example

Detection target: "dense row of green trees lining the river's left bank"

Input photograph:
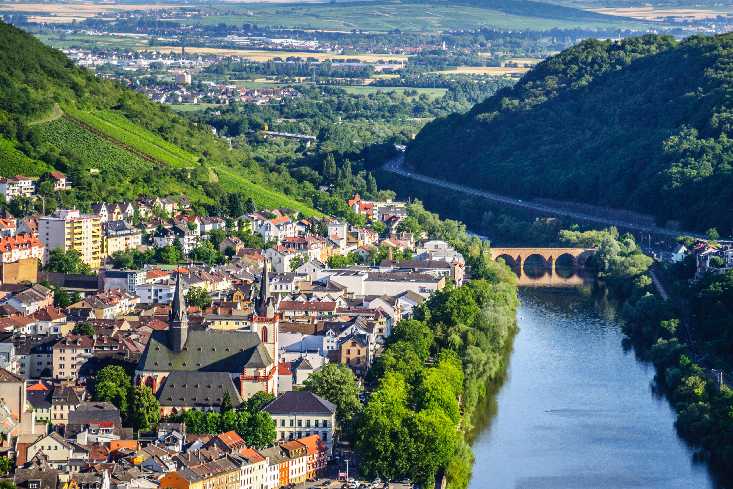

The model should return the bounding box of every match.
[356,247,518,489]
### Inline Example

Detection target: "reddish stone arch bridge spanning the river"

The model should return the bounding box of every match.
[491,247,596,287]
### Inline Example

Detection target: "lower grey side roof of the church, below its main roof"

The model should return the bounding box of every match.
[158,371,242,408]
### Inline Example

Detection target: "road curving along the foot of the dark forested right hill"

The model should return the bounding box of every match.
[383,155,702,238]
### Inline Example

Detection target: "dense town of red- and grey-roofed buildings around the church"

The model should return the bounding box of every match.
[0,172,466,489]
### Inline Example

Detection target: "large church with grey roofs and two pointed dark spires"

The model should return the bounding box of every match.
[135,263,279,415]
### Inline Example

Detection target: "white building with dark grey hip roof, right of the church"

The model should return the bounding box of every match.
[263,391,336,454]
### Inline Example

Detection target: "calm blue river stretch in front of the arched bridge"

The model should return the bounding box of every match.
[469,289,720,489]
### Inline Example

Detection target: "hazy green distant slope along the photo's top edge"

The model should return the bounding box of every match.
[190,2,633,32]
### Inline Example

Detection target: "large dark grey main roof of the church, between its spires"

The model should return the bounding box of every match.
[138,329,273,374]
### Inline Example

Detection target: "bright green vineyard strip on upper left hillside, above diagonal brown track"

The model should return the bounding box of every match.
[67,110,198,168]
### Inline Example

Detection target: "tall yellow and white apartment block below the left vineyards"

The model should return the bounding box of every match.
[38,209,102,268]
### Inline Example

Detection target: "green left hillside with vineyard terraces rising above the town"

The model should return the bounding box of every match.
[0,22,316,214]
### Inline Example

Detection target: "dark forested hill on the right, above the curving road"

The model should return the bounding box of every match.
[407,35,733,236]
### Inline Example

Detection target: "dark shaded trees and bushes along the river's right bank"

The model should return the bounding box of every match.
[560,229,733,478]
